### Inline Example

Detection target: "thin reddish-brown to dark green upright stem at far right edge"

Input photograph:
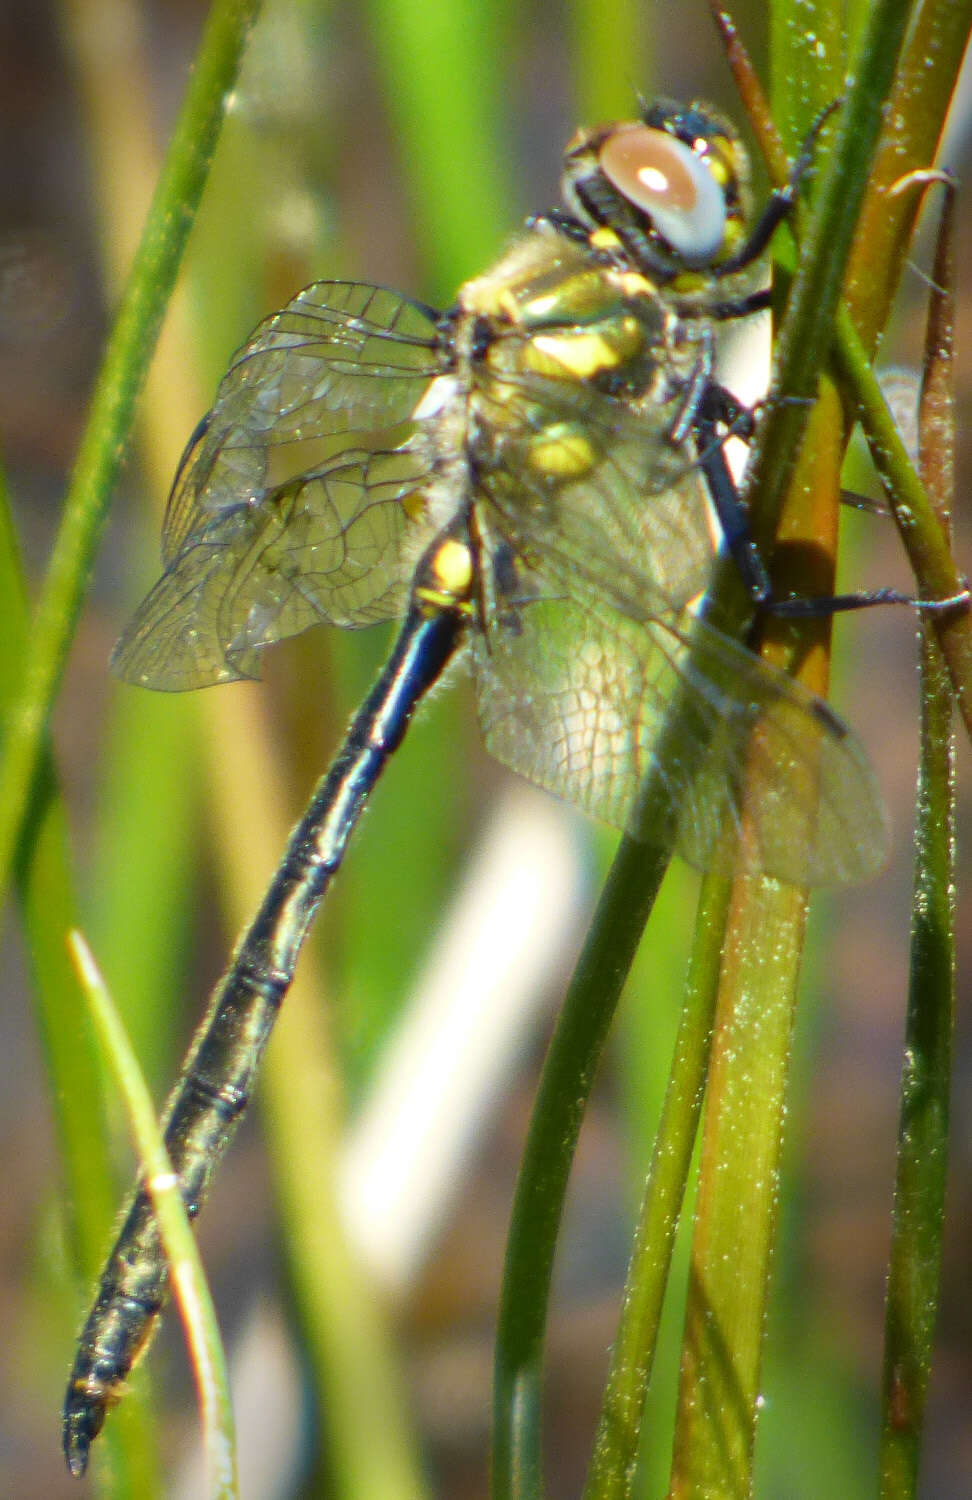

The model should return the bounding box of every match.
[881,170,956,1500]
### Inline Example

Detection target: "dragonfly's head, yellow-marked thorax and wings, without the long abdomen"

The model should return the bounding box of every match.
[114,104,885,882]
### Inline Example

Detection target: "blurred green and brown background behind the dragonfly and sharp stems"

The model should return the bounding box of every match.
[0,0,972,1500]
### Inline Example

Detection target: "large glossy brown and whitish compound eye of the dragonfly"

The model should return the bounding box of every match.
[599,125,726,266]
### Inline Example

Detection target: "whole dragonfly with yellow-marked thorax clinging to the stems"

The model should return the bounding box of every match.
[63,101,887,1475]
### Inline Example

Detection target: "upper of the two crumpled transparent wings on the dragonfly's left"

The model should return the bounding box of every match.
[162,282,443,566]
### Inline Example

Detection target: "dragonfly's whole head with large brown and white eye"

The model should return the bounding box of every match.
[561,99,749,282]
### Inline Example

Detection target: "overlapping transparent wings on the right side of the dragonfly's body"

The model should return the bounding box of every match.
[474,342,888,885]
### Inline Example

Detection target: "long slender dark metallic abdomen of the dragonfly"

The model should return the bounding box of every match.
[63,588,467,1475]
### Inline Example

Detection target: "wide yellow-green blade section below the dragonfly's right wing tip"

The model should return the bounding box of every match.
[671,881,806,1500]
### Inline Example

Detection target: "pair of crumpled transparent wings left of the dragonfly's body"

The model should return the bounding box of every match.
[113,282,444,690]
